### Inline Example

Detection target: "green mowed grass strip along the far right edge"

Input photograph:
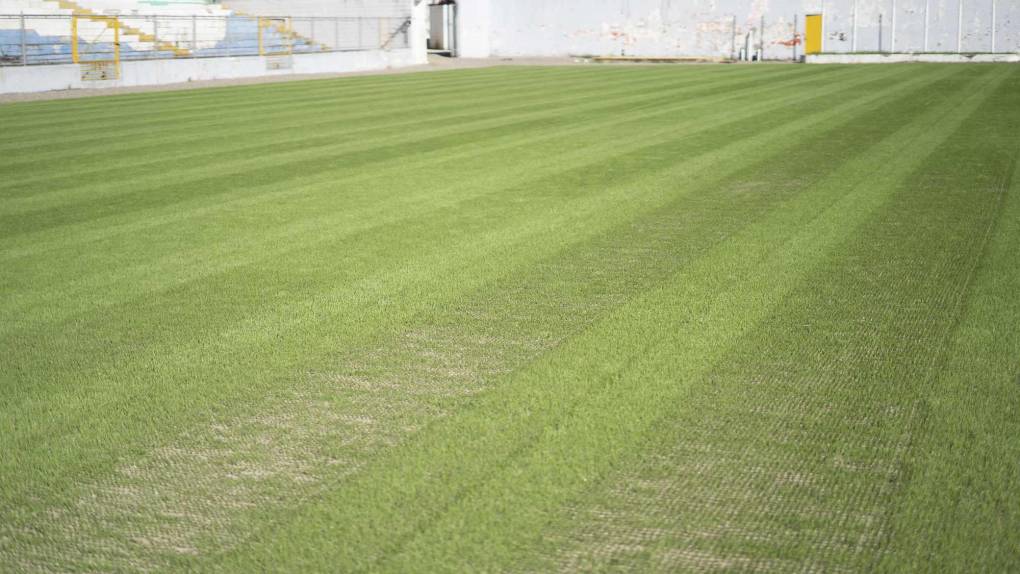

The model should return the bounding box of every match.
[876,136,1020,572]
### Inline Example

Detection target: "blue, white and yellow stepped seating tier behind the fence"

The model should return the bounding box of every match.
[0,0,407,64]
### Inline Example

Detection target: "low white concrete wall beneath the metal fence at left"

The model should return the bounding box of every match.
[0,50,416,94]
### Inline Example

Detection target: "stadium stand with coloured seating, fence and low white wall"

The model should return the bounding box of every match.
[0,0,425,94]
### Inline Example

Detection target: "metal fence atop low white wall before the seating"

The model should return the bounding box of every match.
[0,14,410,66]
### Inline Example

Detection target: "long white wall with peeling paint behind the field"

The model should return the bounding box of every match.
[458,0,1020,59]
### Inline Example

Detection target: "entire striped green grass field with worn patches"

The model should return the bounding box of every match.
[0,64,1020,572]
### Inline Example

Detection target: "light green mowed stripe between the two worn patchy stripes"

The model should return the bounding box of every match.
[200,65,1003,570]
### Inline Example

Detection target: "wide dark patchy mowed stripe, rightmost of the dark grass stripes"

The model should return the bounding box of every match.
[534,66,1016,571]
